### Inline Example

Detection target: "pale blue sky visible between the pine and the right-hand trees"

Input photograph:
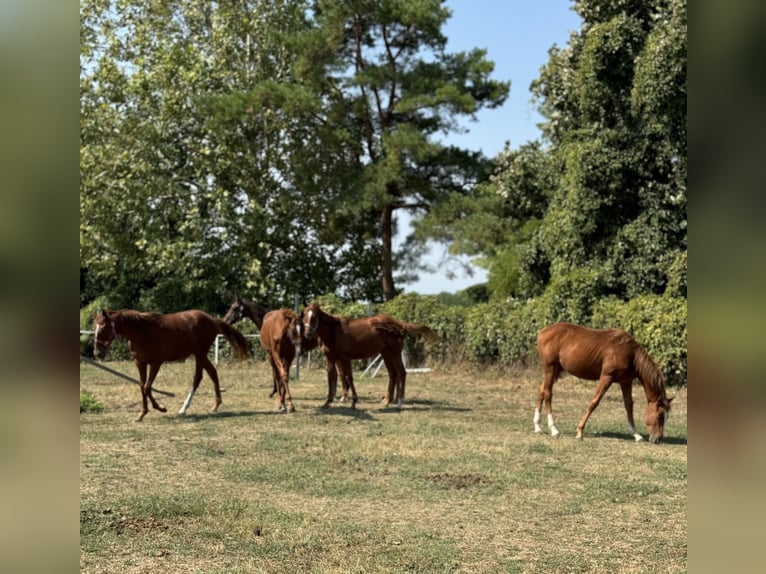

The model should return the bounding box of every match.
[399,0,580,294]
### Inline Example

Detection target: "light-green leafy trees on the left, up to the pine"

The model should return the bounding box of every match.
[80,0,342,310]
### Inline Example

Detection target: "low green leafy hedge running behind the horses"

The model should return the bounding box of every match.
[80,292,687,385]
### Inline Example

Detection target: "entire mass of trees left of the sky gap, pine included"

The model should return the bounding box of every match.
[80,0,508,313]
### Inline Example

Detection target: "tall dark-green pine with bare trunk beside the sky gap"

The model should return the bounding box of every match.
[280,0,509,300]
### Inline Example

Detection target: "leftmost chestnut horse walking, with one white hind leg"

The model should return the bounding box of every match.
[93,309,248,421]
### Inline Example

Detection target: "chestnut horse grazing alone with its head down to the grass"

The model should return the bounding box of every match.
[533,323,673,443]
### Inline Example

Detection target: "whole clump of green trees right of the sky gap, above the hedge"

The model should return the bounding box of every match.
[444,0,687,300]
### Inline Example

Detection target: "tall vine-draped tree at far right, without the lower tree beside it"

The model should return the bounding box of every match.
[522,0,687,299]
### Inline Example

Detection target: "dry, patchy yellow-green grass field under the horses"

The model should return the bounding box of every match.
[80,361,687,574]
